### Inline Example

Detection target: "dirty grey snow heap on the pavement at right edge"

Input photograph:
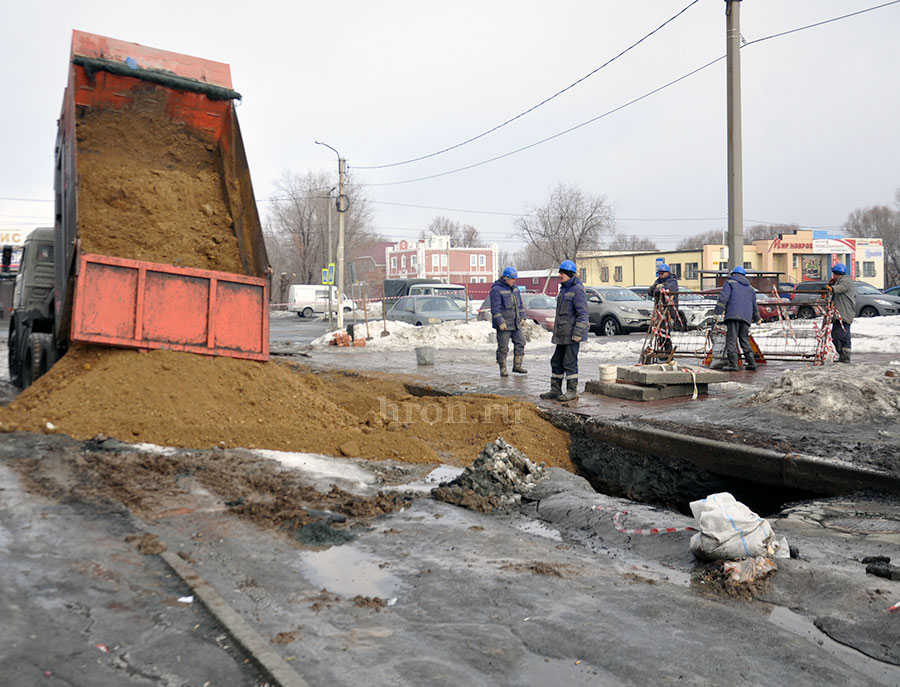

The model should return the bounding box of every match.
[745,364,900,423]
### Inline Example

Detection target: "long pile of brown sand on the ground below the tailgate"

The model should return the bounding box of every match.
[0,345,574,470]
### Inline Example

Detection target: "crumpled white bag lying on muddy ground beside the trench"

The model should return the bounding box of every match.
[691,492,775,560]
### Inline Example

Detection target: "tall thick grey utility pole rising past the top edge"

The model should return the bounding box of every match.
[725,0,744,268]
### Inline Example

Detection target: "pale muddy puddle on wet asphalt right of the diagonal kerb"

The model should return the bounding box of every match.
[299,546,401,599]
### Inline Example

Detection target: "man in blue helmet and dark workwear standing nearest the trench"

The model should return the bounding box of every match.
[541,260,589,401]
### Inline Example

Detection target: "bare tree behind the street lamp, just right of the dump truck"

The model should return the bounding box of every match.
[263,172,378,284]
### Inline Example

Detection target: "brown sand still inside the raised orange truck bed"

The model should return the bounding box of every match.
[77,100,243,274]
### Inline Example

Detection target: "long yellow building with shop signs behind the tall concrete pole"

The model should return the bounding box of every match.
[578,230,885,290]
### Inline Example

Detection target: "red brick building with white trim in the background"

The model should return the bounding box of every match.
[385,235,497,284]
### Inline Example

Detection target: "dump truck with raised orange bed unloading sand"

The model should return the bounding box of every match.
[9,31,271,388]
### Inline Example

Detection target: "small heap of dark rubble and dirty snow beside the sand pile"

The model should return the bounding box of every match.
[431,437,544,513]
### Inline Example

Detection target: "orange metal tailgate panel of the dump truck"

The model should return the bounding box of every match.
[71,253,269,360]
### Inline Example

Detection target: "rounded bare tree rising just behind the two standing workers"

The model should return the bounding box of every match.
[515,182,615,266]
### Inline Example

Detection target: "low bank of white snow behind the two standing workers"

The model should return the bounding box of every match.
[312,320,550,351]
